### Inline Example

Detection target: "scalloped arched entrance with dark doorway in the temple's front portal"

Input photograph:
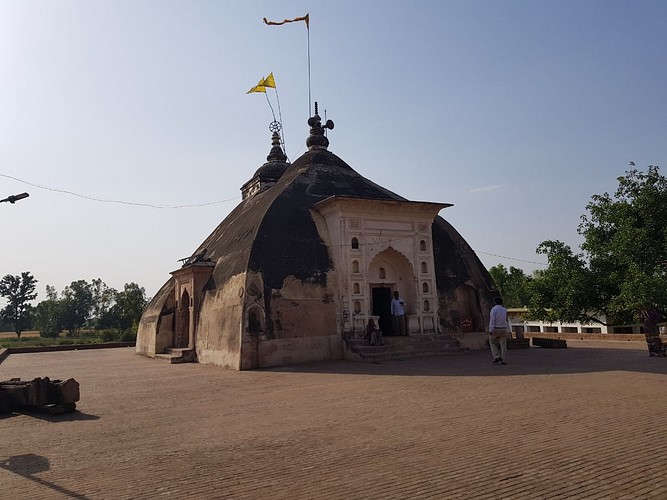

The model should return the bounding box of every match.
[366,247,417,335]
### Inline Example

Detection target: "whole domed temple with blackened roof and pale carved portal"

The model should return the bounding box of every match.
[136,108,494,370]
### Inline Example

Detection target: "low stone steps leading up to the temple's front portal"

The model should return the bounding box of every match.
[345,334,468,362]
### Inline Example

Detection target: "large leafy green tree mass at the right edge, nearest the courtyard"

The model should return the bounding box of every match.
[531,166,667,324]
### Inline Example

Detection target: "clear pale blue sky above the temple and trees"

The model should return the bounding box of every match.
[0,0,667,300]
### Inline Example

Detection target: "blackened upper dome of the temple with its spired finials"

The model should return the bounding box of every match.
[185,110,488,290]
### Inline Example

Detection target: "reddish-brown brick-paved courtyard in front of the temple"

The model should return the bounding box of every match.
[0,341,667,500]
